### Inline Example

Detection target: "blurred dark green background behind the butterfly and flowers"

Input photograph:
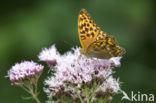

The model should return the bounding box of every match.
[0,0,156,103]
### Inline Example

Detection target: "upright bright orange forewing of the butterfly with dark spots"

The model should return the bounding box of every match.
[78,9,100,52]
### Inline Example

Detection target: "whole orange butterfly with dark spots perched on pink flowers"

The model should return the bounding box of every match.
[78,9,125,59]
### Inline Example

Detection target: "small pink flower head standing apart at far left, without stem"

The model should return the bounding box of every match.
[8,61,44,85]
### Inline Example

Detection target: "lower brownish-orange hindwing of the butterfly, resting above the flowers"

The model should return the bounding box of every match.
[86,36,125,59]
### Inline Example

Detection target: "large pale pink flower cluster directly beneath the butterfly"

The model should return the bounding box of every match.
[39,45,121,101]
